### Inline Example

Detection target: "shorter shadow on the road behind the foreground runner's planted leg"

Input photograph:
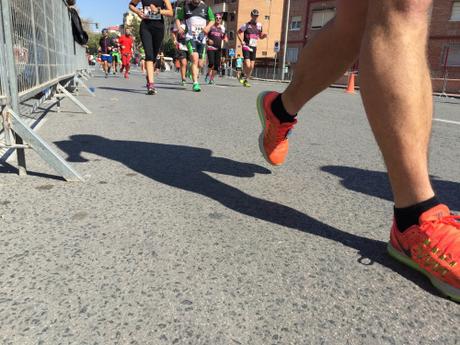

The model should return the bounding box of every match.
[321,165,460,211]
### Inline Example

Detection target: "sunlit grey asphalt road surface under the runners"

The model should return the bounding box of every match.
[0,71,460,345]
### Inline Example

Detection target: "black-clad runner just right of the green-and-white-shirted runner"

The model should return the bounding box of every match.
[206,13,228,84]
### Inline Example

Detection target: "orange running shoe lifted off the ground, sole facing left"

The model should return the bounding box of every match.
[257,92,297,165]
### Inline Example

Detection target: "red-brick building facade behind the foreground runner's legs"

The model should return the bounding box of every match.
[281,0,460,79]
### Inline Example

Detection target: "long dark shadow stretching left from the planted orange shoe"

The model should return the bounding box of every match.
[55,135,438,295]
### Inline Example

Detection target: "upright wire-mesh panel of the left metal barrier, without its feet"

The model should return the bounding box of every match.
[0,0,86,96]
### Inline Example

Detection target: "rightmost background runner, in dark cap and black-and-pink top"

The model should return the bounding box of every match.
[238,10,267,87]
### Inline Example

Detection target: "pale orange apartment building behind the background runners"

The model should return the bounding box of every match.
[205,0,284,62]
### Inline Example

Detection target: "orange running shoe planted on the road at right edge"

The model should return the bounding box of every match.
[388,205,460,302]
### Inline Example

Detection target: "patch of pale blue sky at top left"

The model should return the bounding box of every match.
[77,0,174,30]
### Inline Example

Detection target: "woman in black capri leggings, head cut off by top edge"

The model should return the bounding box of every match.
[129,0,174,95]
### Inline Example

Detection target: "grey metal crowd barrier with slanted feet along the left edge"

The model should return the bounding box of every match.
[0,0,94,180]
